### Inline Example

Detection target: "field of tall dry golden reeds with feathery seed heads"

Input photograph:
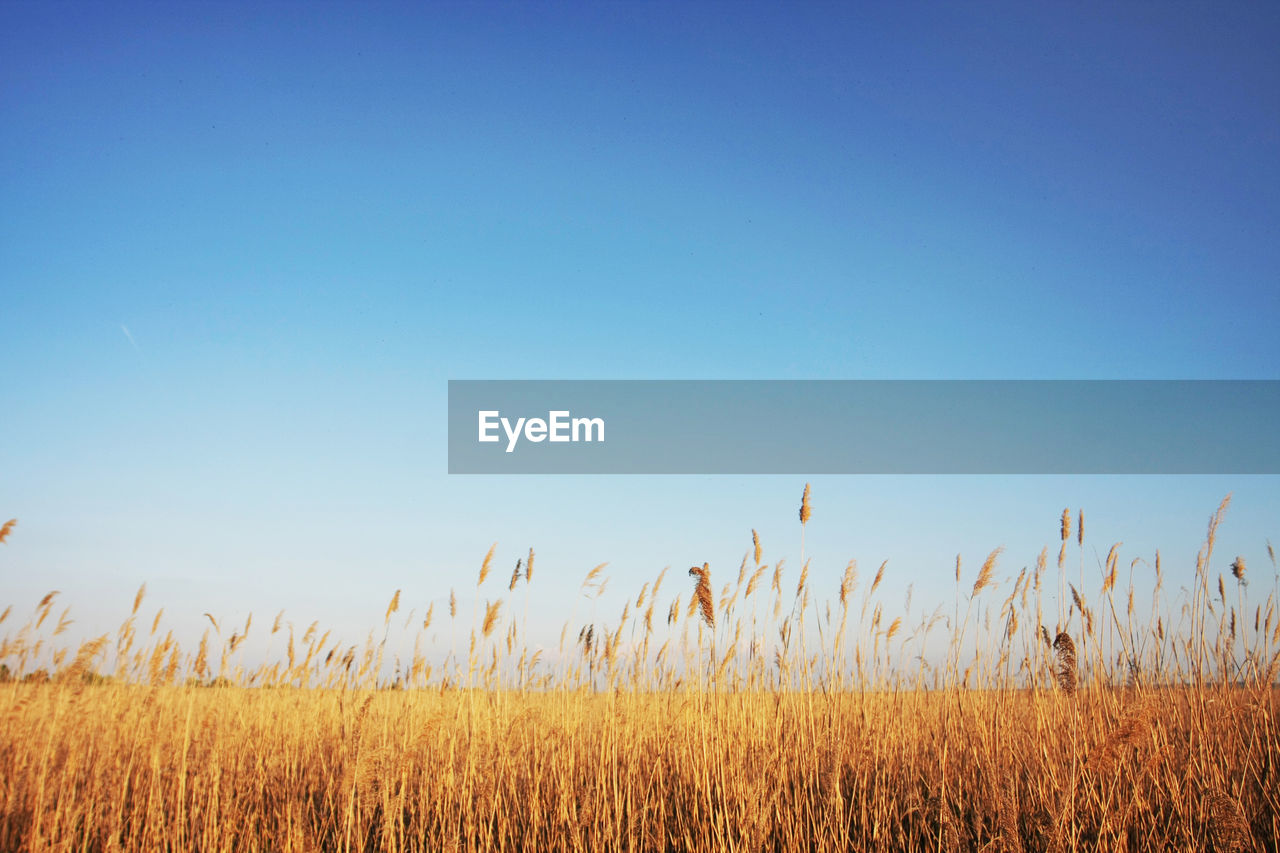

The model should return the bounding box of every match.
[0,487,1280,852]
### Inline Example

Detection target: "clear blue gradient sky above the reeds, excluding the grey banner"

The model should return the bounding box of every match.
[0,3,1280,655]
